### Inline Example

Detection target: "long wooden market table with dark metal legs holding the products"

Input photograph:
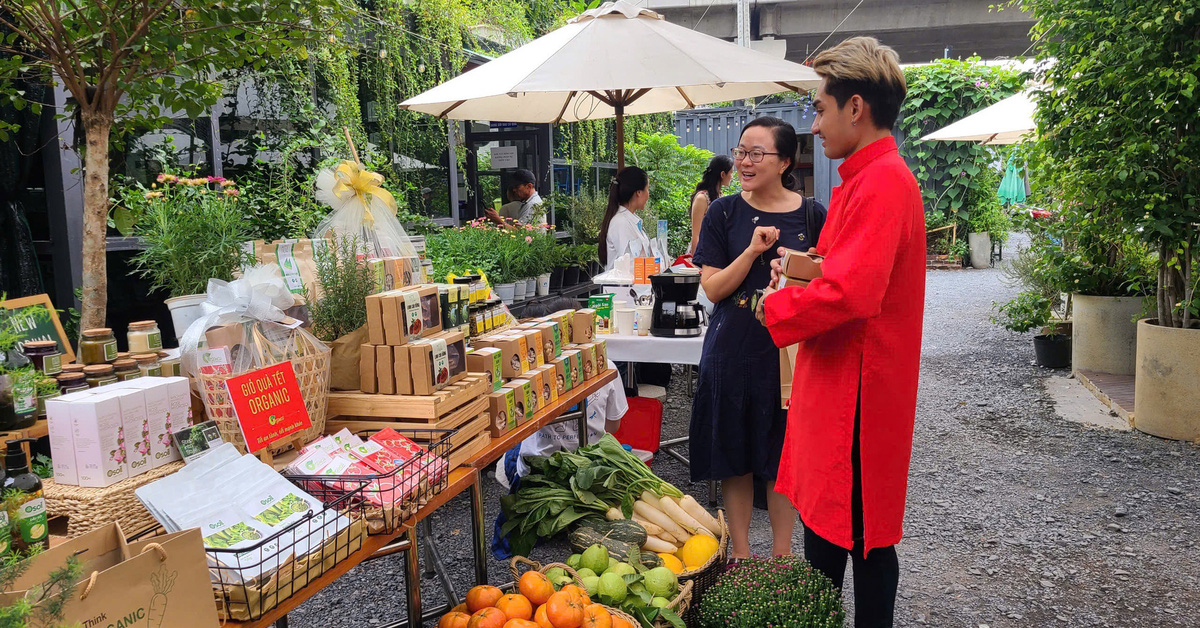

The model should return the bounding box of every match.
[226,370,617,628]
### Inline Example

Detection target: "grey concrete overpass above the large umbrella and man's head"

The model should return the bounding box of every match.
[631,0,1033,64]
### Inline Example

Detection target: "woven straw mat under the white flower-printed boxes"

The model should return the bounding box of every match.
[42,461,184,538]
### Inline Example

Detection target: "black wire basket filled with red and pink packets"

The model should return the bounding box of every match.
[284,429,457,534]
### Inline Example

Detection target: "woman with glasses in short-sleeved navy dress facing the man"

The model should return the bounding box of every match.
[690,116,826,558]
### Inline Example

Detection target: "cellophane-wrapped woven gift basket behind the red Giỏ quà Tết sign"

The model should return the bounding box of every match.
[194,324,330,454]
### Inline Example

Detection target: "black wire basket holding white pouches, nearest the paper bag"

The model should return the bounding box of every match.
[129,479,367,621]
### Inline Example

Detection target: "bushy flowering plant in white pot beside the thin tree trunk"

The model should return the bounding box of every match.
[129,174,253,337]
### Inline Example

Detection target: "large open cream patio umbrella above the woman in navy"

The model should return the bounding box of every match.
[400,0,820,166]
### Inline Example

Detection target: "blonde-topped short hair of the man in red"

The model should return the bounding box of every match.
[812,37,908,128]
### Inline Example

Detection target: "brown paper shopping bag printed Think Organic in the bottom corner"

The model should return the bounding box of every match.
[0,524,217,628]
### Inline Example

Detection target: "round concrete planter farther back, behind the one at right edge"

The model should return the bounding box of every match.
[1070,294,1142,375]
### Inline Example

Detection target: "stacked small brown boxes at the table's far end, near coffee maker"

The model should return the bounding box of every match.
[467,309,608,438]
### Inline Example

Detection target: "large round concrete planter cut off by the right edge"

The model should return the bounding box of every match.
[1133,318,1200,441]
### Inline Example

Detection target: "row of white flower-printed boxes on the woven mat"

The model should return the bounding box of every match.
[46,377,191,488]
